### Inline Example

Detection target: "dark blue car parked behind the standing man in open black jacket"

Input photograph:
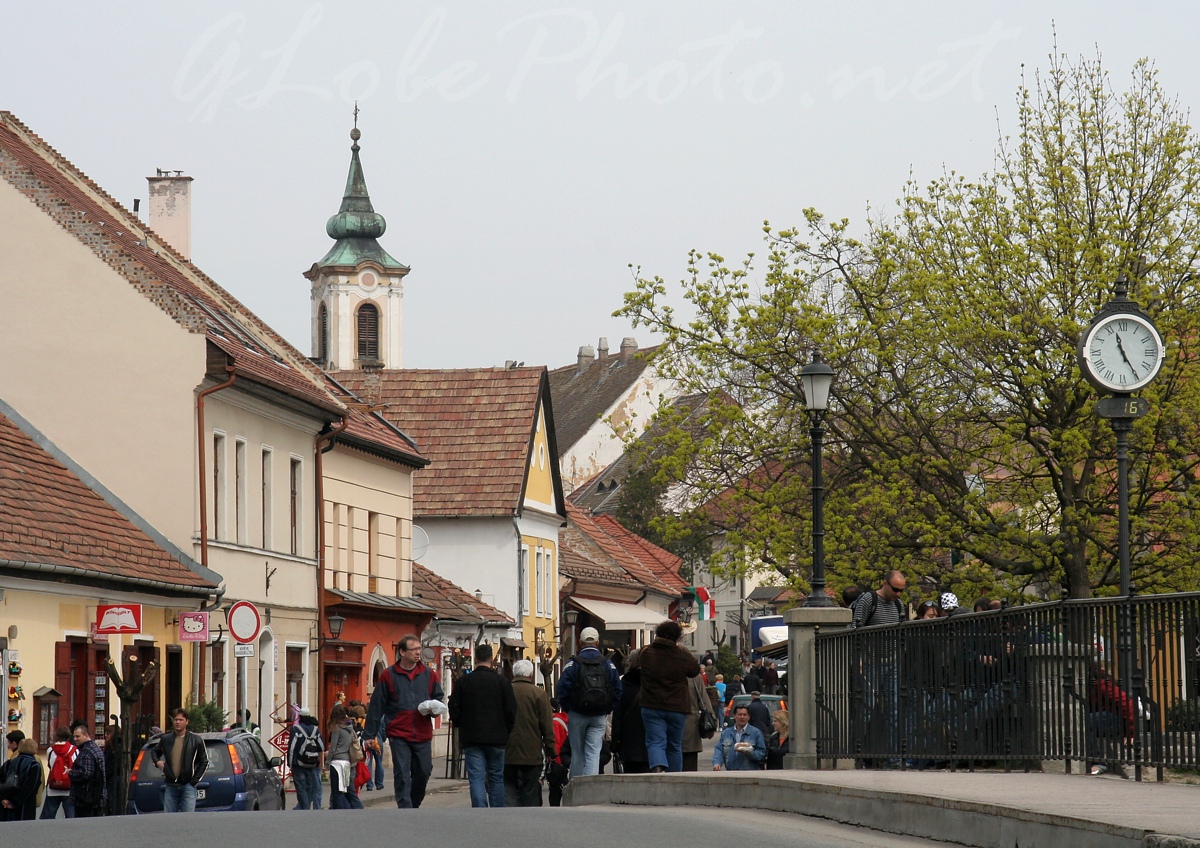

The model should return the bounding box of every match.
[127,729,287,816]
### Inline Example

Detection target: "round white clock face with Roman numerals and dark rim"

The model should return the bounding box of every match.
[1079,312,1165,393]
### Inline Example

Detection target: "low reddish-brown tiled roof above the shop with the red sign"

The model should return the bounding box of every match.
[0,400,216,595]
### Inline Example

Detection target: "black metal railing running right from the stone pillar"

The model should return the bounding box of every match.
[814,593,1200,780]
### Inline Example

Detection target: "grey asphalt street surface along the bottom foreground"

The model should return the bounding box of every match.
[0,793,946,848]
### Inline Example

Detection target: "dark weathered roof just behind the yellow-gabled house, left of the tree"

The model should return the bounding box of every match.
[550,347,658,456]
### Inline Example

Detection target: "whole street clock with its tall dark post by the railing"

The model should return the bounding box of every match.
[1078,273,1165,781]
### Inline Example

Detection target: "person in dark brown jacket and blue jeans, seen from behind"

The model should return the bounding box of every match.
[638,620,700,771]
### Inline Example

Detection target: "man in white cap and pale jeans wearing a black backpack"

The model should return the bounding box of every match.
[558,627,620,777]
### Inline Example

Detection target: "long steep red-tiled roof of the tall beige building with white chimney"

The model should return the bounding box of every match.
[0,112,342,413]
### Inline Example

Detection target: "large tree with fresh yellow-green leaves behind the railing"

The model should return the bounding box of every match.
[618,55,1200,597]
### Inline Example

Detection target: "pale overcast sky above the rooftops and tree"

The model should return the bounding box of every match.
[0,0,1200,368]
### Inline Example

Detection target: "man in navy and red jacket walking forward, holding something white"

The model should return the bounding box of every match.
[365,633,445,810]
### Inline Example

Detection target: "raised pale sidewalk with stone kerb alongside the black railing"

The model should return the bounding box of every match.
[563,770,1200,848]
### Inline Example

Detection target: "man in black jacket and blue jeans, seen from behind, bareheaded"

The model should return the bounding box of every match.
[449,645,517,807]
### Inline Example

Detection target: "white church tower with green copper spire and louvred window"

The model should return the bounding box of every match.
[304,121,409,371]
